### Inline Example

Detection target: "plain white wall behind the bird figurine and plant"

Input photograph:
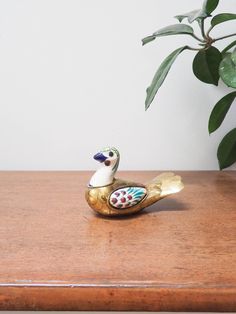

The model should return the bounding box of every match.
[0,0,236,170]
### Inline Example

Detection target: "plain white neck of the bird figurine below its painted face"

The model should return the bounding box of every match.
[89,166,116,187]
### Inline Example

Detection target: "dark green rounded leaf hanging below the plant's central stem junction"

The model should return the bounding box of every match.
[193,46,222,86]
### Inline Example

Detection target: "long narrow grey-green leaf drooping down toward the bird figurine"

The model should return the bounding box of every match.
[145,46,188,110]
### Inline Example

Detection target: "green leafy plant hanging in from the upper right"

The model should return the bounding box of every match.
[142,0,236,169]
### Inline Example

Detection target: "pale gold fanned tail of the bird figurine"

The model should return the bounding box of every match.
[148,172,184,198]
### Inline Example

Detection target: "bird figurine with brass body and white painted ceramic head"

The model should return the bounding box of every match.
[85,147,183,216]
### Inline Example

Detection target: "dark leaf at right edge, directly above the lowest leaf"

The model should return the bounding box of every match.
[208,92,236,133]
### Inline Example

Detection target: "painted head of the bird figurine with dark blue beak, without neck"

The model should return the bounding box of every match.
[93,147,120,171]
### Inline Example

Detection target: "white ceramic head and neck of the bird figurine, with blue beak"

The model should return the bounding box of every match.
[89,147,120,187]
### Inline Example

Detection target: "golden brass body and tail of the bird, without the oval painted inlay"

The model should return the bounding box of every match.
[85,173,183,216]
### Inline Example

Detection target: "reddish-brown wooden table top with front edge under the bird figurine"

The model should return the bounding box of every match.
[0,171,236,312]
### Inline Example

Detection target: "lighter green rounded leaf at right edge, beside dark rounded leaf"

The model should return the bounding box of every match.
[219,53,236,88]
